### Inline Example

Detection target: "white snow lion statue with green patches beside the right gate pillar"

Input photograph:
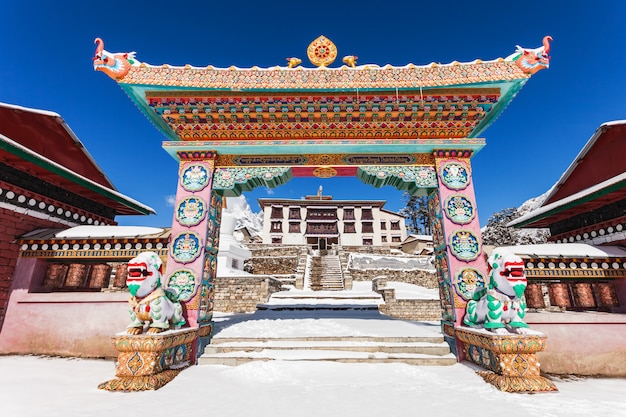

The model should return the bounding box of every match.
[463,248,528,334]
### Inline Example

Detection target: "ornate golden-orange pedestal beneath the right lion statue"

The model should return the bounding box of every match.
[454,327,558,392]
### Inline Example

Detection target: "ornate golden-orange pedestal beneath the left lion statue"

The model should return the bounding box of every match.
[98,328,198,391]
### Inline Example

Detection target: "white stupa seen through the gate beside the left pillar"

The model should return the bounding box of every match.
[217,199,252,277]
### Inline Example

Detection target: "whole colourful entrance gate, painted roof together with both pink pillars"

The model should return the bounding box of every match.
[94,36,551,358]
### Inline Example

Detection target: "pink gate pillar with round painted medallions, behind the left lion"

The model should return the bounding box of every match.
[164,151,222,359]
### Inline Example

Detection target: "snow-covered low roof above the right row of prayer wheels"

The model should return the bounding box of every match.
[502,243,626,258]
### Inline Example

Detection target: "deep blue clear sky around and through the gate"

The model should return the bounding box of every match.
[0,0,626,226]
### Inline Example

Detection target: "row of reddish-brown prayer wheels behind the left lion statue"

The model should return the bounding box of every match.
[42,263,128,289]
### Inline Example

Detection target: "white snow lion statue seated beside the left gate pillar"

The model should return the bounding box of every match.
[126,252,185,334]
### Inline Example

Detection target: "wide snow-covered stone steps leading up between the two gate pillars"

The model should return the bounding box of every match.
[198,283,456,366]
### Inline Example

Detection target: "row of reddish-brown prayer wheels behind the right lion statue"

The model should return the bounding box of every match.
[524,282,619,309]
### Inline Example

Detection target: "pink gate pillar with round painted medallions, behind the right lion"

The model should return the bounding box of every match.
[430,150,487,360]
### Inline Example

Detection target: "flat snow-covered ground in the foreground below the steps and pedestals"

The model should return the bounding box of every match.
[0,356,626,417]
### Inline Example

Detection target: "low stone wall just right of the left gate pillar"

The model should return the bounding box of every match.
[213,276,282,313]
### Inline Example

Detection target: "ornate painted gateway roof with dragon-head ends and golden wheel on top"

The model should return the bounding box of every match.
[94,36,552,157]
